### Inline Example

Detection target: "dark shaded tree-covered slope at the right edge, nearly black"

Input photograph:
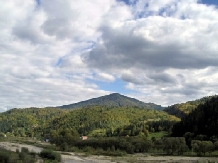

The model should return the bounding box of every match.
[172,96,218,139]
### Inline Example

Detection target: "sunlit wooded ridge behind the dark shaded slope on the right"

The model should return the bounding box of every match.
[163,95,217,118]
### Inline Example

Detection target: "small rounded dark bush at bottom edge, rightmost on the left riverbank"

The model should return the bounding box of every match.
[39,149,61,162]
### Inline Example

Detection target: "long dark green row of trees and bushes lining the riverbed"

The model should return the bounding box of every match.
[48,133,218,156]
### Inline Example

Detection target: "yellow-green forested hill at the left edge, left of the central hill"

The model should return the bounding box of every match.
[0,108,68,137]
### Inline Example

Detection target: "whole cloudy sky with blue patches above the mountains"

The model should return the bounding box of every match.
[0,0,218,112]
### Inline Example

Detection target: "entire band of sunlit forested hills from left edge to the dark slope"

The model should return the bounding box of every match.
[0,106,179,138]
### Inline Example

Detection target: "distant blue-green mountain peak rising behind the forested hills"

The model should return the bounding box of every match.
[58,93,163,110]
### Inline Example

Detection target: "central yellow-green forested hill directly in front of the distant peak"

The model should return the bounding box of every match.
[49,106,180,136]
